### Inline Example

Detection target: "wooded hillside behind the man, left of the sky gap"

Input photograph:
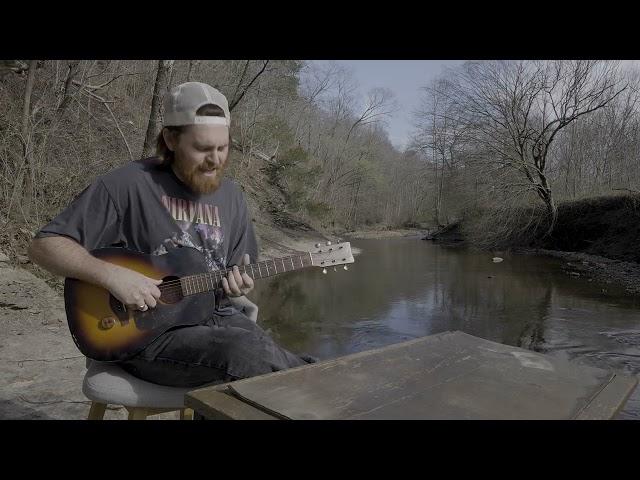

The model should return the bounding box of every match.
[0,60,410,260]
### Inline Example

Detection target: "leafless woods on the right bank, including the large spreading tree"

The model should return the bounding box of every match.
[413,60,639,245]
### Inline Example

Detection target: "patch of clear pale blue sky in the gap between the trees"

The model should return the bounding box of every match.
[313,60,463,150]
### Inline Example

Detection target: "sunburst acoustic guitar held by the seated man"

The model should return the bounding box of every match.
[64,242,354,362]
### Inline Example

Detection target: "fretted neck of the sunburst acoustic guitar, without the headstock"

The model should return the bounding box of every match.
[180,253,313,296]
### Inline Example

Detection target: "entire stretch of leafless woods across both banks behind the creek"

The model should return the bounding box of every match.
[0,60,640,258]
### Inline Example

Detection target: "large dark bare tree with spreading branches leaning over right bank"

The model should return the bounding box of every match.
[444,60,626,232]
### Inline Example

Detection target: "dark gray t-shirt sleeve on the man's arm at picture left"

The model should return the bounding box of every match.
[36,179,120,251]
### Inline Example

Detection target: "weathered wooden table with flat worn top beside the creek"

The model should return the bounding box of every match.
[185,331,637,420]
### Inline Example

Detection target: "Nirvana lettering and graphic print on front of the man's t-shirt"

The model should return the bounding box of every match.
[152,195,227,271]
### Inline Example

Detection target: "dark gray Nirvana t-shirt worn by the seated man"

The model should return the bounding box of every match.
[36,157,258,314]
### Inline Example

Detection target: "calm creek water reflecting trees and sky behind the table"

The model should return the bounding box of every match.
[253,238,640,418]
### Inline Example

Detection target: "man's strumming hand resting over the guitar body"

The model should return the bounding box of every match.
[104,264,162,311]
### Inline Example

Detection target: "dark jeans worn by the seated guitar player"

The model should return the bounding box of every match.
[120,313,316,387]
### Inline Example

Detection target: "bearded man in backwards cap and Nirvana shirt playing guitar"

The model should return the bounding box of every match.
[29,82,314,387]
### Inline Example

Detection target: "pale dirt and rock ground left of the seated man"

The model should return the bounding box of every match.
[0,259,102,419]
